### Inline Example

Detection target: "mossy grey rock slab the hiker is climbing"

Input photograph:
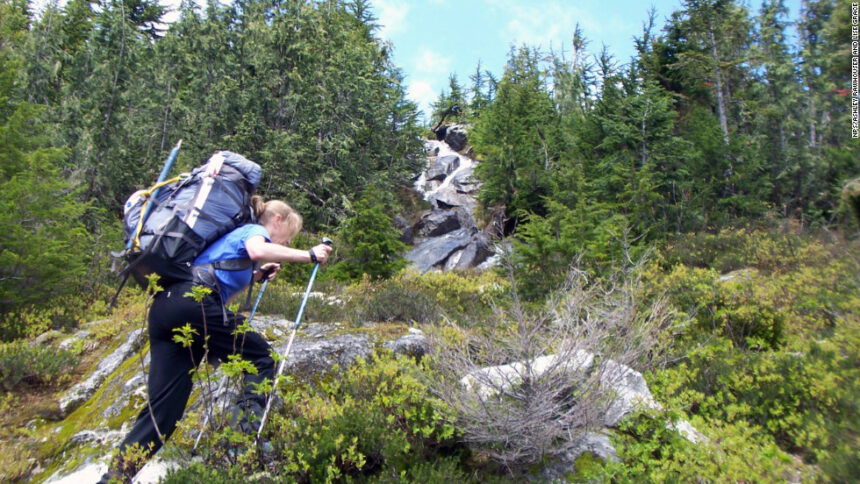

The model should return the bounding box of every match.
[42,316,429,484]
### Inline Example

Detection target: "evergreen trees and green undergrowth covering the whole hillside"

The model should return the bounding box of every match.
[0,0,860,483]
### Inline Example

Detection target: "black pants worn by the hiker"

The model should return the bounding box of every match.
[119,282,275,455]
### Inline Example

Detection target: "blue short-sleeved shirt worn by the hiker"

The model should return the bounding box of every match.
[194,224,271,303]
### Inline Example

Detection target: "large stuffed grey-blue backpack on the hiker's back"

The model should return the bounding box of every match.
[113,151,262,294]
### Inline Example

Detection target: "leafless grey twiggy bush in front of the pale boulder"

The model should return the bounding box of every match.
[434,260,675,475]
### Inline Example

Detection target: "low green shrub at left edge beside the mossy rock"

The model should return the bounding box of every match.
[0,340,78,391]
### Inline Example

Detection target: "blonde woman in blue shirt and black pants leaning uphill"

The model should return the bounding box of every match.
[99,196,332,483]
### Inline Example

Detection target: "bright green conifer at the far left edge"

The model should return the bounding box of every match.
[0,2,92,339]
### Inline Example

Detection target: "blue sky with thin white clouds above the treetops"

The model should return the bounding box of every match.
[371,0,800,121]
